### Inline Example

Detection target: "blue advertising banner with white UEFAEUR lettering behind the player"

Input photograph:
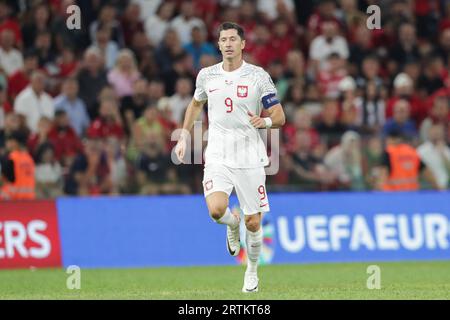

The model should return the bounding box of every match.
[57,192,450,267]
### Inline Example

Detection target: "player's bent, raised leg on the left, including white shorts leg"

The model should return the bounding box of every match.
[203,165,241,256]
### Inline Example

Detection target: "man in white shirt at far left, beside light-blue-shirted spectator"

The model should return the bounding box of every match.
[14,71,54,132]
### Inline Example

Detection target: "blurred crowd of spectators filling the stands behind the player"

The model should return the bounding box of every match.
[0,0,450,198]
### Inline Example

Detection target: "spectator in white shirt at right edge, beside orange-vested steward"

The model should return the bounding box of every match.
[417,124,450,189]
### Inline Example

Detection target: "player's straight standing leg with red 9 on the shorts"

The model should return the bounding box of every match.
[235,168,269,292]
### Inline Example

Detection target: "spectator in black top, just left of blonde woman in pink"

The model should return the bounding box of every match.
[77,48,108,119]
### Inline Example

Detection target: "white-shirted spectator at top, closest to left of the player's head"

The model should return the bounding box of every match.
[171,1,205,45]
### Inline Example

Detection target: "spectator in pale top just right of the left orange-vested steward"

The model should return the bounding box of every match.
[35,143,63,199]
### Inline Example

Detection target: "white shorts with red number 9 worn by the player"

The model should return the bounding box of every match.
[203,164,270,215]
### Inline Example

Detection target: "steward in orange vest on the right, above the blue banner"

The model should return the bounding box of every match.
[377,129,439,191]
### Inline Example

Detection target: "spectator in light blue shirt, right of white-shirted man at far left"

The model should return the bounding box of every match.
[54,78,90,137]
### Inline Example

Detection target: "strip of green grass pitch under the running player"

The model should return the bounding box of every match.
[0,261,450,300]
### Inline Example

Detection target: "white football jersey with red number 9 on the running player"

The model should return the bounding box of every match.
[194,61,278,168]
